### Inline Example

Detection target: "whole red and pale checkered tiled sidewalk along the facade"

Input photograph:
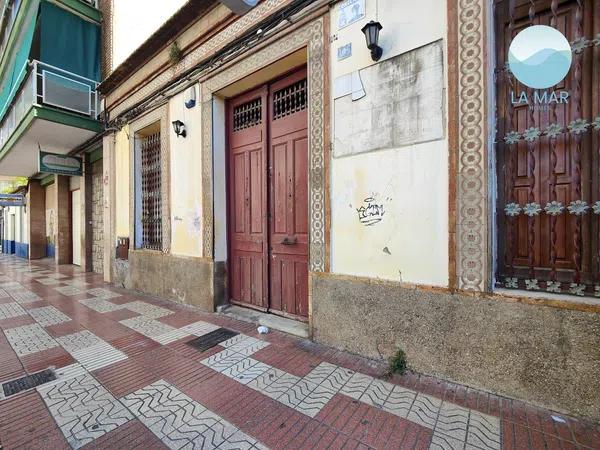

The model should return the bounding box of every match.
[0,256,600,449]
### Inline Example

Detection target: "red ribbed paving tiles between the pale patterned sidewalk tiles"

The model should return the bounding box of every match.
[0,263,600,450]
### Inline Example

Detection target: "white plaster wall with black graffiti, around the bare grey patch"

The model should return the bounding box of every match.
[331,0,448,286]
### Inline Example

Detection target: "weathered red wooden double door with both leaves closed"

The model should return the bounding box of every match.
[227,70,309,320]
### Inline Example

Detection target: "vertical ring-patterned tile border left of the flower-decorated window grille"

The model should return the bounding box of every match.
[450,0,490,291]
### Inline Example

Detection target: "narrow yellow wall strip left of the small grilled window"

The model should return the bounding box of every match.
[115,125,130,237]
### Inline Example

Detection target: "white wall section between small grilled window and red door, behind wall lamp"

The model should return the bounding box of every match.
[169,85,202,256]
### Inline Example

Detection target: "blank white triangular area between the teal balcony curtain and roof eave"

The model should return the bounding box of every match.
[112,0,186,69]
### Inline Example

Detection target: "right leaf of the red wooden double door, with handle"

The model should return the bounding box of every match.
[269,71,308,319]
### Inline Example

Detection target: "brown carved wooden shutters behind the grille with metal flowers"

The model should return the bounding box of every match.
[495,0,600,295]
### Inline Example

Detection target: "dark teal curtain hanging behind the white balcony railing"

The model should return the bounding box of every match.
[40,1,100,81]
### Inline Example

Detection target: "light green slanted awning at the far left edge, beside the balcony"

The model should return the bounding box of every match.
[0,16,36,121]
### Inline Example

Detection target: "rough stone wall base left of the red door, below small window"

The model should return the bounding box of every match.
[125,250,215,311]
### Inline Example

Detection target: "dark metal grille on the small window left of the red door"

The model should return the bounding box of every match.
[141,132,162,250]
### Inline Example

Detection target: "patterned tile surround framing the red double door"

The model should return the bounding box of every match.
[201,16,330,324]
